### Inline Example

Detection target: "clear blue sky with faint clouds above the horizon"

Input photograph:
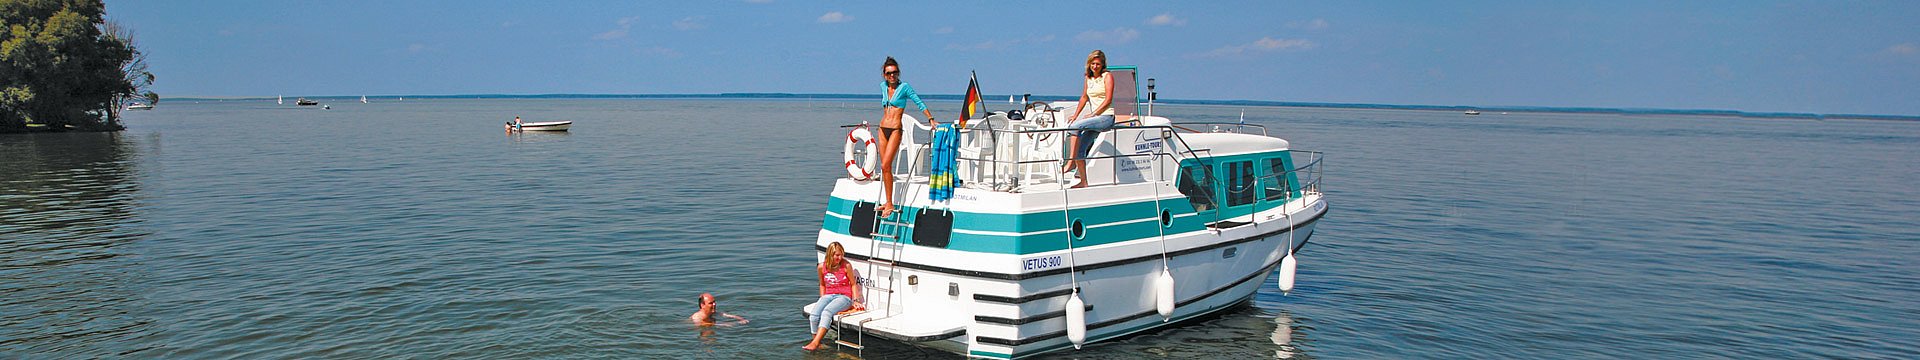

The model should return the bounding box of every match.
[108,0,1920,115]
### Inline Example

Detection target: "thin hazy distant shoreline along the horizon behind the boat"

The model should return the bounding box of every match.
[163,92,1920,121]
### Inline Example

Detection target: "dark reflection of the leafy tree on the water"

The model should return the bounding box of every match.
[0,132,156,356]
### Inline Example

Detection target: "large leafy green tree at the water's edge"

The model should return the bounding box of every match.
[0,0,154,132]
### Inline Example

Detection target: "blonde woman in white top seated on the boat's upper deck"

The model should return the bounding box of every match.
[1060,50,1114,188]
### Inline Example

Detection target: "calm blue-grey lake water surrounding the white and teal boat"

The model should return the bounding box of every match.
[0,100,1920,358]
